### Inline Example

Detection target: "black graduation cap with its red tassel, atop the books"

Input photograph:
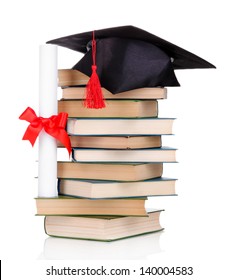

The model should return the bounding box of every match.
[47,25,215,108]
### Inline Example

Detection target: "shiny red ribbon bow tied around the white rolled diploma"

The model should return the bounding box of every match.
[19,107,72,155]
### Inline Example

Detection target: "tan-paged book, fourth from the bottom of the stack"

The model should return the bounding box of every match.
[57,161,163,181]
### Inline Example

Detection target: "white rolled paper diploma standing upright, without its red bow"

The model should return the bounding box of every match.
[38,44,58,197]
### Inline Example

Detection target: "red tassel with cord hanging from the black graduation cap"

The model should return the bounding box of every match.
[84,31,105,109]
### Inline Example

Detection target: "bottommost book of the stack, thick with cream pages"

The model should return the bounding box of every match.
[44,210,163,241]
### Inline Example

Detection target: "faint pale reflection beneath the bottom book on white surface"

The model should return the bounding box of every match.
[38,231,163,260]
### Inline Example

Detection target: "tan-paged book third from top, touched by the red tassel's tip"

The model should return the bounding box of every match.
[58,99,158,118]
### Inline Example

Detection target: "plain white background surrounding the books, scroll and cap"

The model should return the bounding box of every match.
[0,0,237,279]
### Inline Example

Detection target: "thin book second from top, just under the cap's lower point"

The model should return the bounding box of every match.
[61,86,167,100]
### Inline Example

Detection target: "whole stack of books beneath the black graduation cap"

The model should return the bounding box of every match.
[36,69,176,241]
